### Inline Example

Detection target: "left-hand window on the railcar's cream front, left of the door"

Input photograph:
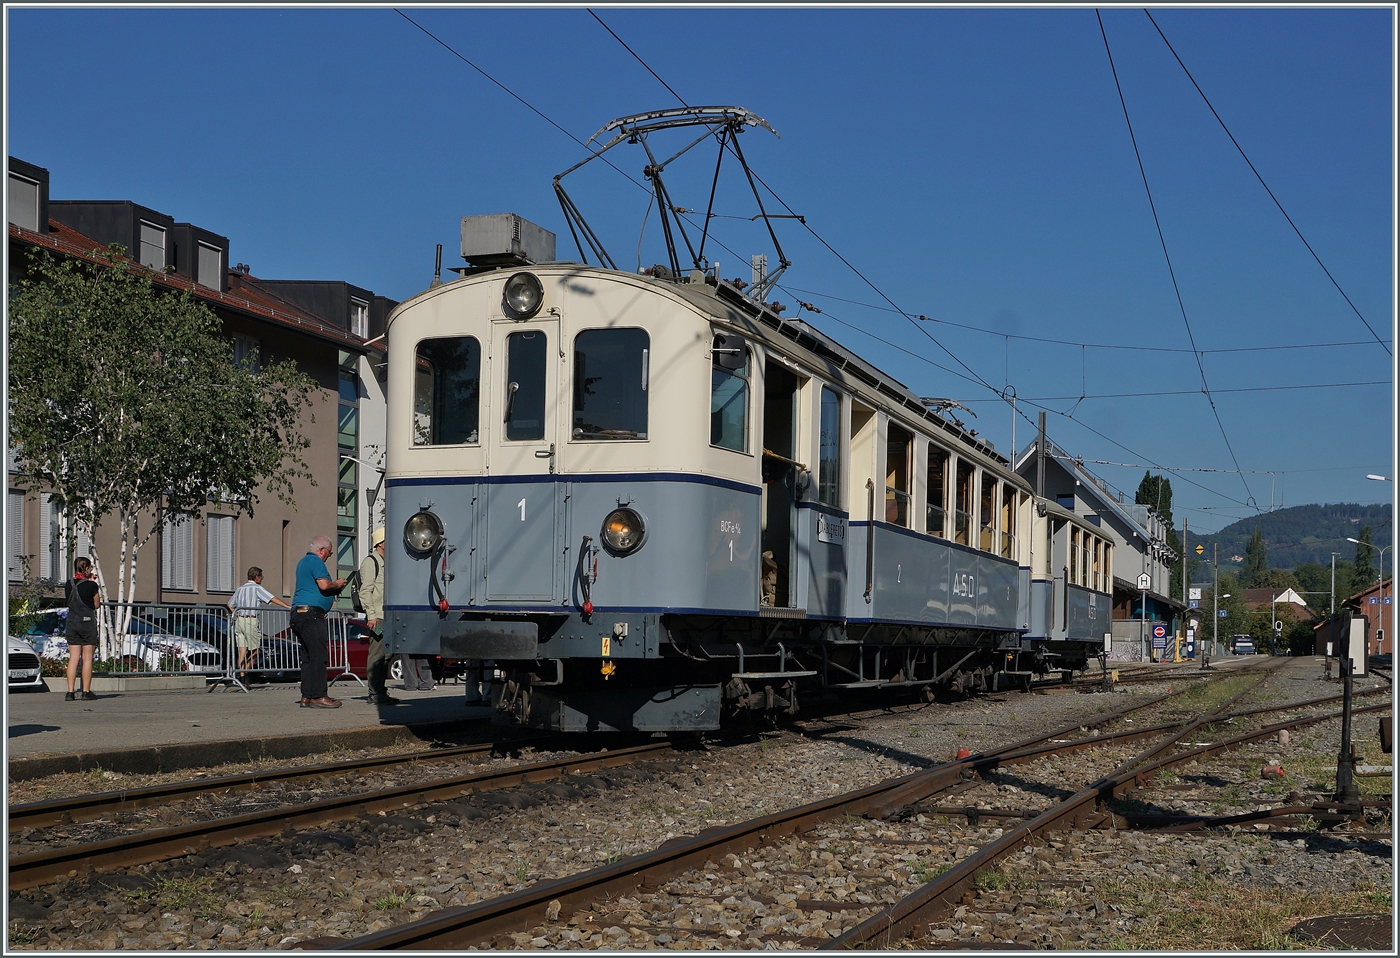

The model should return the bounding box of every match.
[413,336,482,445]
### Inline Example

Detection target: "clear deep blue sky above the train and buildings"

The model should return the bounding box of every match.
[6,7,1394,532]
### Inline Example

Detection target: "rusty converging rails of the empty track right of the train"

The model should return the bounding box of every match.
[298,658,1389,950]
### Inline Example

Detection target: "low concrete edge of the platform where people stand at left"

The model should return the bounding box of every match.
[7,721,461,782]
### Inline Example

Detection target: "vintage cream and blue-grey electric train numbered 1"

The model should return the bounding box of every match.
[385,217,1113,730]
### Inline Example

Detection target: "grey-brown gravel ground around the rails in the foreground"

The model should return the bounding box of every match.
[8,660,1390,950]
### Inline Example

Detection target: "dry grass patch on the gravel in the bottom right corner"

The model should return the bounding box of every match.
[1095,874,1390,951]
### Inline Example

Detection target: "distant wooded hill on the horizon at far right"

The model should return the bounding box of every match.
[1186,503,1392,573]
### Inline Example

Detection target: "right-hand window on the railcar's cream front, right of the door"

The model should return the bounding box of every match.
[573,329,651,440]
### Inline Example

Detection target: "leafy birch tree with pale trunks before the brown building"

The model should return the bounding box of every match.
[8,247,315,649]
